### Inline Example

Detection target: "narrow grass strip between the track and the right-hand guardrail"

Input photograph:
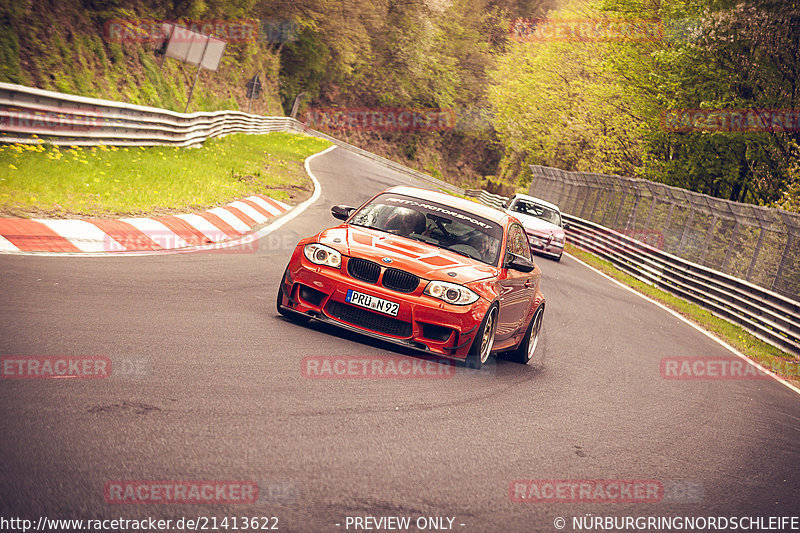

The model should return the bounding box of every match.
[566,244,800,385]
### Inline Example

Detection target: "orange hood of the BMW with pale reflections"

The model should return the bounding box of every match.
[317,224,498,283]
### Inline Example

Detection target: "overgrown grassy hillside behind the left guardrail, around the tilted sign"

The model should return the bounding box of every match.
[0,0,283,115]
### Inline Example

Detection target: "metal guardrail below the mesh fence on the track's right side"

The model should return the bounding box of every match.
[476,191,800,355]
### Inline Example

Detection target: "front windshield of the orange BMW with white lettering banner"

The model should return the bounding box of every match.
[350,193,503,266]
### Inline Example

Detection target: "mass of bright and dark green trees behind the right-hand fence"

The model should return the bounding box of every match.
[490,0,800,205]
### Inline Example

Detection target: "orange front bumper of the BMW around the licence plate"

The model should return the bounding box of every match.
[281,252,490,359]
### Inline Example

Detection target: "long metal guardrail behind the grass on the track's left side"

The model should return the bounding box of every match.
[0,83,464,195]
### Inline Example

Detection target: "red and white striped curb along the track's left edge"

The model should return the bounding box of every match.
[0,194,291,253]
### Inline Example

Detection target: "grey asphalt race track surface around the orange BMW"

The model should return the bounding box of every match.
[0,145,800,532]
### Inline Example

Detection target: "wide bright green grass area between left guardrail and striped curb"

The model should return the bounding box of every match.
[0,133,330,218]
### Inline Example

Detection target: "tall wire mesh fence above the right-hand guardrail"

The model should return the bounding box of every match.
[530,165,800,300]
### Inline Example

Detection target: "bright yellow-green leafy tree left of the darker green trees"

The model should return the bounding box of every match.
[489,1,642,183]
